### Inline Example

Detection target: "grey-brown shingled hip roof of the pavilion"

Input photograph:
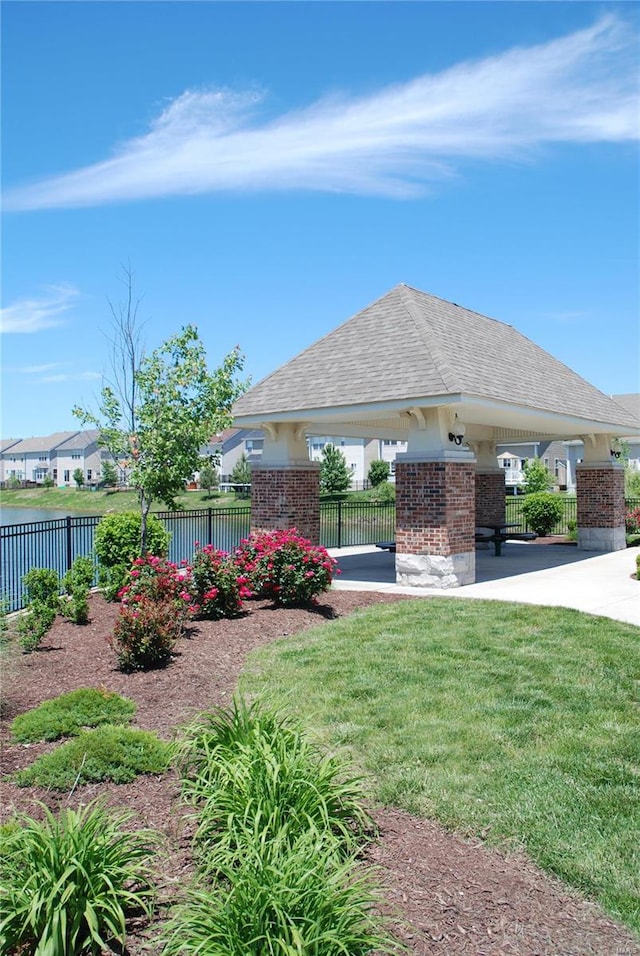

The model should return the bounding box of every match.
[234,284,638,440]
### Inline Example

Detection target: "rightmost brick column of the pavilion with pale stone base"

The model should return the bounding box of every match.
[576,462,627,551]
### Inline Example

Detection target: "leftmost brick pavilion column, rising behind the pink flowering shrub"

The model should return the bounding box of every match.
[251,462,320,544]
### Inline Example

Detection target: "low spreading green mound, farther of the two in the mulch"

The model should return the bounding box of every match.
[11,687,136,743]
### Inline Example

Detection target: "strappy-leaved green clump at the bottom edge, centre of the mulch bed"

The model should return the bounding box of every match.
[163,830,390,956]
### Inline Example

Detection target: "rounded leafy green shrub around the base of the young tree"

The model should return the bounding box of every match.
[93,511,171,601]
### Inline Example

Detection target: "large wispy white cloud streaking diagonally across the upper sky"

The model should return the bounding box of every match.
[5,15,640,210]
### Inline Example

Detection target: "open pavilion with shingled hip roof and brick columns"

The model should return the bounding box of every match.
[234,284,640,588]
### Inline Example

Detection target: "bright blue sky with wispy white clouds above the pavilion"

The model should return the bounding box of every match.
[0,0,640,438]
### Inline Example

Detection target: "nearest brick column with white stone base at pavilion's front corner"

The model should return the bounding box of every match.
[396,458,475,588]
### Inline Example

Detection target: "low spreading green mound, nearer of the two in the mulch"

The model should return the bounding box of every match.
[14,724,171,790]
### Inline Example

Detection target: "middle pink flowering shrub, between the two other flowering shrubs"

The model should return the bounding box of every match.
[190,545,251,621]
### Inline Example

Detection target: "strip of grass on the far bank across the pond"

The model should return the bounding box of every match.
[0,488,250,515]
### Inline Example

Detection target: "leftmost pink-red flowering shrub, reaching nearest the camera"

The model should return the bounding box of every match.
[111,555,192,671]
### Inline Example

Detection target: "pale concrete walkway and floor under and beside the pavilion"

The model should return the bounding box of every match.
[329,541,640,627]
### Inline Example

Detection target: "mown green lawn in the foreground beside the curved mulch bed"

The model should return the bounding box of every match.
[242,598,640,932]
